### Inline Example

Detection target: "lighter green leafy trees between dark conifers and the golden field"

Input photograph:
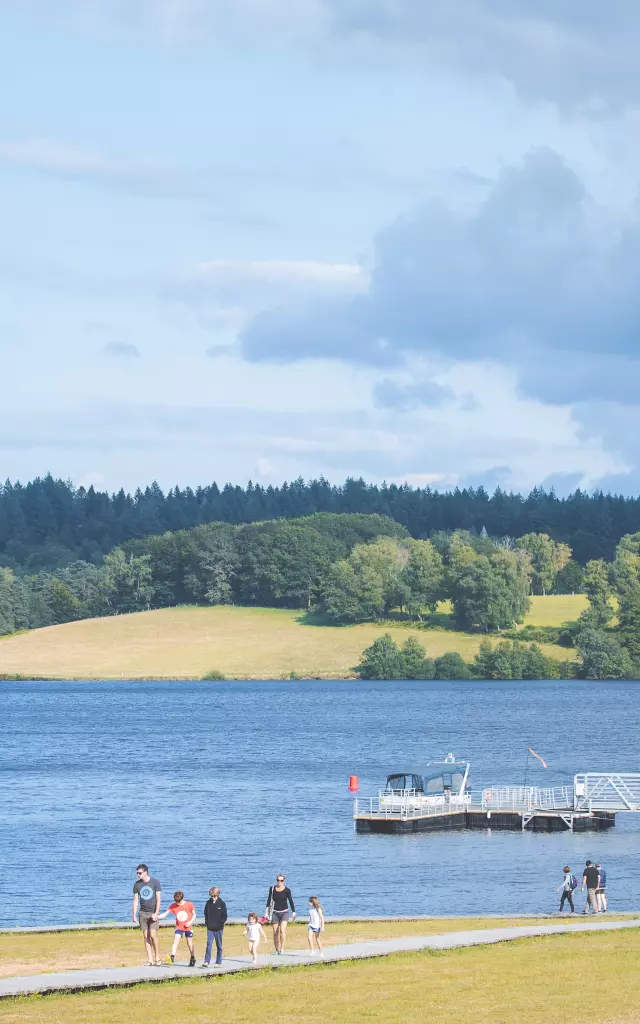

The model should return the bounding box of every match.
[0,497,640,678]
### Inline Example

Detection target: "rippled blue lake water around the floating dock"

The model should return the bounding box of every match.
[0,681,640,927]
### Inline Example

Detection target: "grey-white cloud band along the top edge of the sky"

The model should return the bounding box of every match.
[68,0,640,108]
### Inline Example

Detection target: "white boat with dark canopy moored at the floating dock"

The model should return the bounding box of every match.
[379,754,471,810]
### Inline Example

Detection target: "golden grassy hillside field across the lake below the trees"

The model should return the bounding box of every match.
[0,595,587,679]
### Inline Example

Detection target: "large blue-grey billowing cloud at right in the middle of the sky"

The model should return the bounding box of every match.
[241,150,640,401]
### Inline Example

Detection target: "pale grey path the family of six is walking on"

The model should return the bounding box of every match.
[0,920,640,999]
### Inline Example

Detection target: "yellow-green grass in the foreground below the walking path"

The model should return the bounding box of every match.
[0,930,640,1024]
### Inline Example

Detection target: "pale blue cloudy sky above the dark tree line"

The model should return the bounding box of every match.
[0,0,640,494]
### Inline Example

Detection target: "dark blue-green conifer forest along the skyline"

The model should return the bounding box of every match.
[0,476,640,572]
